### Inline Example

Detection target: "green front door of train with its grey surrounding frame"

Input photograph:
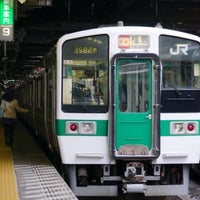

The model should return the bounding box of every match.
[112,54,160,158]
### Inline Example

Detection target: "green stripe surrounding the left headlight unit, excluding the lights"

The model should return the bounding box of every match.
[56,120,108,136]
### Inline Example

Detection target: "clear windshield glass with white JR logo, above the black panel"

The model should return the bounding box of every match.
[159,36,200,90]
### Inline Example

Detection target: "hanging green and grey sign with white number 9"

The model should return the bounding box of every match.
[0,0,14,41]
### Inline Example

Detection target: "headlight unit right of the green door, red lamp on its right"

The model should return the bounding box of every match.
[170,122,198,135]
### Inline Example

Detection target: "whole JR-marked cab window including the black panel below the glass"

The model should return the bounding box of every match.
[159,35,200,113]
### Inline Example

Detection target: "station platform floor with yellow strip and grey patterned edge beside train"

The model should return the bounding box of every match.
[0,120,77,200]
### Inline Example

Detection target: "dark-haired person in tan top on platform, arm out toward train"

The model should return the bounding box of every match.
[2,89,28,147]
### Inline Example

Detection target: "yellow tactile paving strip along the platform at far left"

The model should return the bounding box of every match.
[0,123,19,200]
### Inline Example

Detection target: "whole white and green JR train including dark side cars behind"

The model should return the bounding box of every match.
[18,23,200,196]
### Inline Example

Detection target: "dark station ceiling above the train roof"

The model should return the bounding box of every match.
[0,0,200,80]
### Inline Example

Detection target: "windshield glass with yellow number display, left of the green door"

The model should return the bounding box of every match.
[62,35,108,113]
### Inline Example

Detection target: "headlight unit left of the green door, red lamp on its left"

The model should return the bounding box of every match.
[65,121,96,134]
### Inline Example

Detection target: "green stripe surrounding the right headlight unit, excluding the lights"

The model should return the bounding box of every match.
[160,120,200,136]
